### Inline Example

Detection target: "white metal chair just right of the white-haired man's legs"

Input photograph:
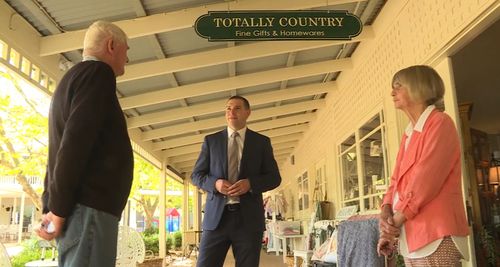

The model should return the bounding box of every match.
[116,226,146,267]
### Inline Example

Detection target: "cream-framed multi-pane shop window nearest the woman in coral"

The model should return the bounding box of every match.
[339,112,388,212]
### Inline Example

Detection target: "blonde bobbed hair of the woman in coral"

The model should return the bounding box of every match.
[392,65,444,111]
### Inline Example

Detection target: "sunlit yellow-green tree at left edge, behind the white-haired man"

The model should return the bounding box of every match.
[0,70,48,209]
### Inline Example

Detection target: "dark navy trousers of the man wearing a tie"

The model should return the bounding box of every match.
[196,204,263,267]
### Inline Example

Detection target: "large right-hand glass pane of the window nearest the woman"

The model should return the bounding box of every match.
[361,129,385,195]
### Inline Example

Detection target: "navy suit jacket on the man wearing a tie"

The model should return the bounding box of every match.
[191,129,281,231]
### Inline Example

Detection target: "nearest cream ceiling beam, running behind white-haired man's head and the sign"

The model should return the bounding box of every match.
[40,0,359,56]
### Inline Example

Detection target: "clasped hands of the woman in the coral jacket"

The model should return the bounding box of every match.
[377,205,405,256]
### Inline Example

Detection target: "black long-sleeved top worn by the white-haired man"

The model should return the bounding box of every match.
[43,61,133,220]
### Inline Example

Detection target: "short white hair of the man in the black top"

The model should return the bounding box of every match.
[83,20,127,55]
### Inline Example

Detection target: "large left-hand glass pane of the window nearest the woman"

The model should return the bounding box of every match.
[342,147,359,199]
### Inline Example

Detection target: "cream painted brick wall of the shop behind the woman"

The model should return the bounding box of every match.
[280,0,498,221]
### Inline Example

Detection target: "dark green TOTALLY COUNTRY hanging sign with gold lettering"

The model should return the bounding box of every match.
[194,10,363,41]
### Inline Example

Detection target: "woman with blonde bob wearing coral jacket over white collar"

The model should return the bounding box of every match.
[377,66,469,266]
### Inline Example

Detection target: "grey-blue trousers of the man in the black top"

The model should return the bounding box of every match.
[57,204,120,267]
